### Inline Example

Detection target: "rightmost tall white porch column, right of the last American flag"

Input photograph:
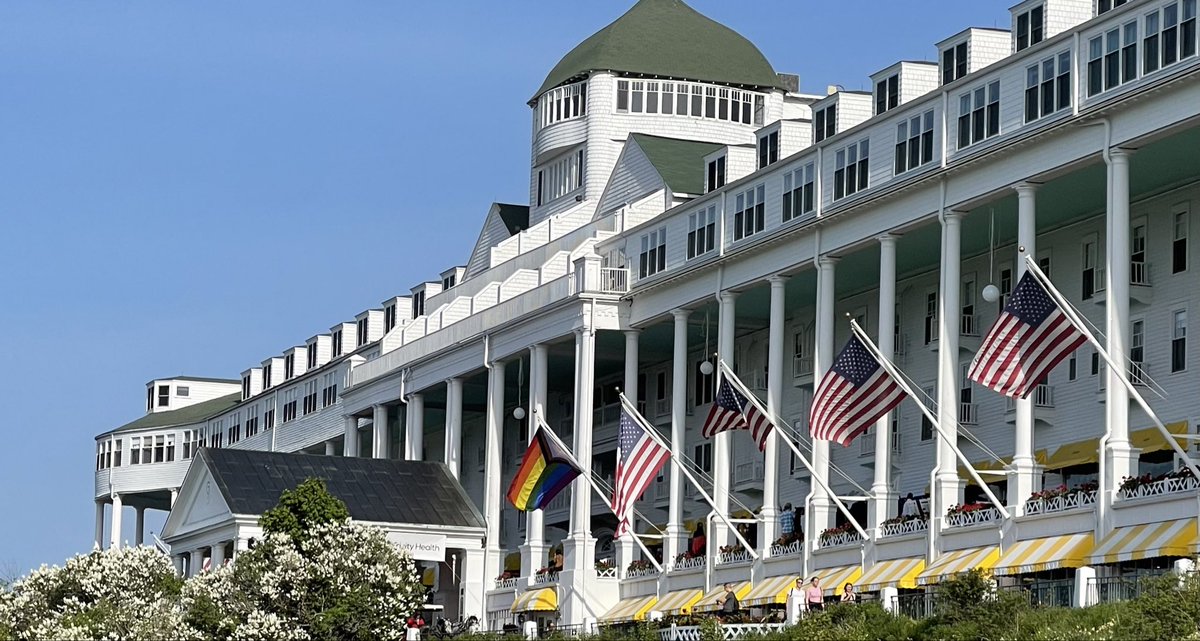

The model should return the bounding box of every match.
[1104,149,1139,482]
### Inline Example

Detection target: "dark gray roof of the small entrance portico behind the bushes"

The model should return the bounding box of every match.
[199,448,484,528]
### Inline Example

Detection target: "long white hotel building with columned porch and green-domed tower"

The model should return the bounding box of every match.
[95,0,1200,628]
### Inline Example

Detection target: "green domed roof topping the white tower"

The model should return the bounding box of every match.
[530,0,780,102]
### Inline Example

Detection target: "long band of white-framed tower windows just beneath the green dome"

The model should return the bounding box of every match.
[617,79,766,125]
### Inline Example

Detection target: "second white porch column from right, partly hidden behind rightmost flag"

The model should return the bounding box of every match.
[1008,182,1042,507]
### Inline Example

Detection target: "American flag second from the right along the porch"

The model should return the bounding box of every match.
[809,336,905,445]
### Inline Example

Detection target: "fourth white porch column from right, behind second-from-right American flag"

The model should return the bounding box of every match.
[864,234,896,528]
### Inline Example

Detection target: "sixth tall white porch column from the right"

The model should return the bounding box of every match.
[758,276,787,557]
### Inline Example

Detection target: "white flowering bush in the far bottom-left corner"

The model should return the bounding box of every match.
[0,547,199,640]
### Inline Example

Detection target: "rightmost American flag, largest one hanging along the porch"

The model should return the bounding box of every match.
[967,271,1087,399]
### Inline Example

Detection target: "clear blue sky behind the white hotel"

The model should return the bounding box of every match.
[0,0,1012,573]
